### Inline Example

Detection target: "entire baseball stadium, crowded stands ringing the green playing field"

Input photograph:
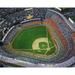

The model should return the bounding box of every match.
[0,8,75,67]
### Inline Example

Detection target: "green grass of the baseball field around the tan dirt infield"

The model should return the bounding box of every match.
[11,26,56,55]
